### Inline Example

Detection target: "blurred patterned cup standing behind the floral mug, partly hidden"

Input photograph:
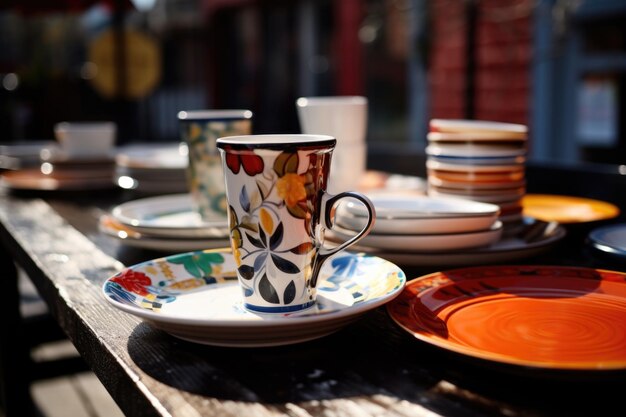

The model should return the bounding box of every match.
[178,110,252,222]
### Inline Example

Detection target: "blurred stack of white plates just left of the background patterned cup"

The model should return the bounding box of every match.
[114,143,188,194]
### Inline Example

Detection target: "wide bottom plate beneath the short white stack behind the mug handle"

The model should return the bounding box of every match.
[352,219,566,268]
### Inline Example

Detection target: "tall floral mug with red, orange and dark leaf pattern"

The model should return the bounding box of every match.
[217,134,375,313]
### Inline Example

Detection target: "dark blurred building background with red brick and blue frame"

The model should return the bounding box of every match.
[0,0,626,164]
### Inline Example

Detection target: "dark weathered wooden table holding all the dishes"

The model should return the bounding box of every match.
[0,161,626,417]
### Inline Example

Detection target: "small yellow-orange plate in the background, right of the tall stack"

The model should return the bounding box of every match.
[522,194,619,224]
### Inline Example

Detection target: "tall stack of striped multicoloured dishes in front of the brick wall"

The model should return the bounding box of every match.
[426,119,528,228]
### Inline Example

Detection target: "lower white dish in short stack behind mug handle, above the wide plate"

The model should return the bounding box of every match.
[327,221,502,252]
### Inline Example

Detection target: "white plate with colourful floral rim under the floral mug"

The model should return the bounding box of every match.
[102,250,406,347]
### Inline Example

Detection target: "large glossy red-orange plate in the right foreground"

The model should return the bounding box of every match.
[387,266,626,371]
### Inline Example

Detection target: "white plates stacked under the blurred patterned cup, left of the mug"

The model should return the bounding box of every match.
[99,194,230,252]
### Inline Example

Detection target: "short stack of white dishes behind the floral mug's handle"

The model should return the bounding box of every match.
[329,195,502,253]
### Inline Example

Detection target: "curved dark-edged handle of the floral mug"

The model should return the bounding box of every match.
[312,191,376,287]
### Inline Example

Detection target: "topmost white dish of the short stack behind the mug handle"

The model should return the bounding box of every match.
[338,194,499,222]
